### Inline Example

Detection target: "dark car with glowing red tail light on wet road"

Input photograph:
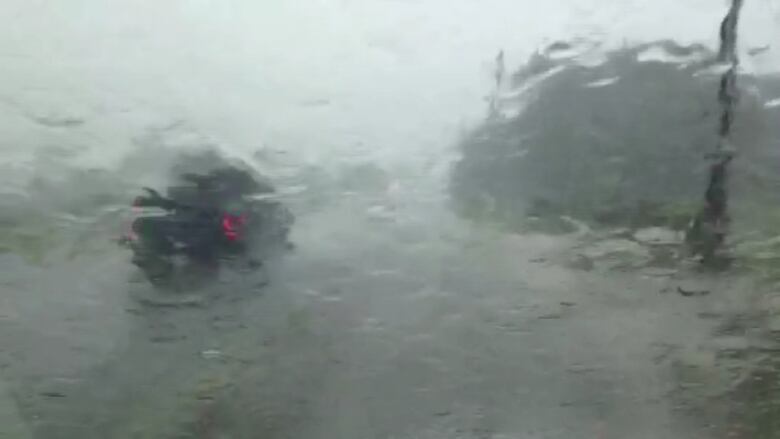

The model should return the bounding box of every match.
[123,167,293,285]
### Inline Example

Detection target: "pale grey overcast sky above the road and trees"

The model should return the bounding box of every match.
[0,0,780,170]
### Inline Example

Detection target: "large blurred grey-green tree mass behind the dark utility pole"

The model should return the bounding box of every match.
[450,41,780,232]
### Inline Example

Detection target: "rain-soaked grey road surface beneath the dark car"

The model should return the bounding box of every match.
[0,190,756,439]
